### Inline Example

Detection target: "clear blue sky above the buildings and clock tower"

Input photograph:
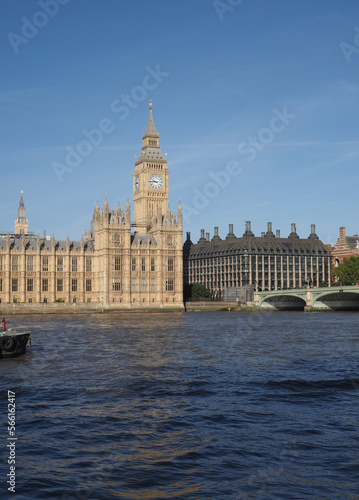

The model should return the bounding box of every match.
[0,0,359,243]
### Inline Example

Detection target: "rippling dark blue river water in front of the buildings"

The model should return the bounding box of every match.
[0,312,359,500]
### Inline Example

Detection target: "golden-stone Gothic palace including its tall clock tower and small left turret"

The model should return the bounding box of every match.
[0,104,183,308]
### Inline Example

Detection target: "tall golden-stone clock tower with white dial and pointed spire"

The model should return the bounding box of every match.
[133,102,169,234]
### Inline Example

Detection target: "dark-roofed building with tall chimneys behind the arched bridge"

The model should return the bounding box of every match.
[183,222,331,297]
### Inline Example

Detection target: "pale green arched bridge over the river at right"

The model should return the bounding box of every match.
[254,285,359,311]
